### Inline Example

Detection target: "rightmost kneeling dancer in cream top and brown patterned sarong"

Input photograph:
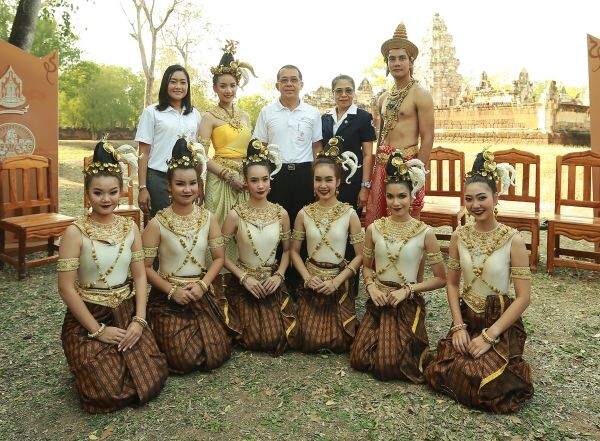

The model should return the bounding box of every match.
[425,150,533,413]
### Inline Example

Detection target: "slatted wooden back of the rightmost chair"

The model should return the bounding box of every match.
[554,150,600,215]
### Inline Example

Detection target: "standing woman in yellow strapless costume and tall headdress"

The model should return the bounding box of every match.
[200,41,254,227]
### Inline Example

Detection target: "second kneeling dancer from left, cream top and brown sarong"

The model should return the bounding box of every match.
[143,138,237,374]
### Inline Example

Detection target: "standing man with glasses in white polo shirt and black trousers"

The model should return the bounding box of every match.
[254,64,323,225]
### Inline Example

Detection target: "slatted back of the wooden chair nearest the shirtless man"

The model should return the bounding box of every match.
[425,147,465,198]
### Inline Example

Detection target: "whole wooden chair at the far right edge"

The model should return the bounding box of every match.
[547,150,600,273]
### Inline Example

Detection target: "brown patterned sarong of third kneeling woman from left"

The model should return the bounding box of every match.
[224,274,300,357]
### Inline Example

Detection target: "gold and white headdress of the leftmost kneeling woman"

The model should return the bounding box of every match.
[83,135,141,185]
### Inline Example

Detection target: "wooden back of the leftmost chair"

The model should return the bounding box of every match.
[0,155,56,219]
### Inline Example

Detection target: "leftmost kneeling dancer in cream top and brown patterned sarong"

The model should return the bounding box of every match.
[57,142,168,413]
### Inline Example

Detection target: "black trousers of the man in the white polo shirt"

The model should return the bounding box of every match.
[269,162,315,299]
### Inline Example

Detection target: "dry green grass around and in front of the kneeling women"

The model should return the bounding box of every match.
[0,145,600,441]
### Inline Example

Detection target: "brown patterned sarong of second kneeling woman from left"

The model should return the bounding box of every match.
[148,276,240,374]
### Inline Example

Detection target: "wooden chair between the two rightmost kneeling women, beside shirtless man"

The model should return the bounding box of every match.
[421,147,466,246]
